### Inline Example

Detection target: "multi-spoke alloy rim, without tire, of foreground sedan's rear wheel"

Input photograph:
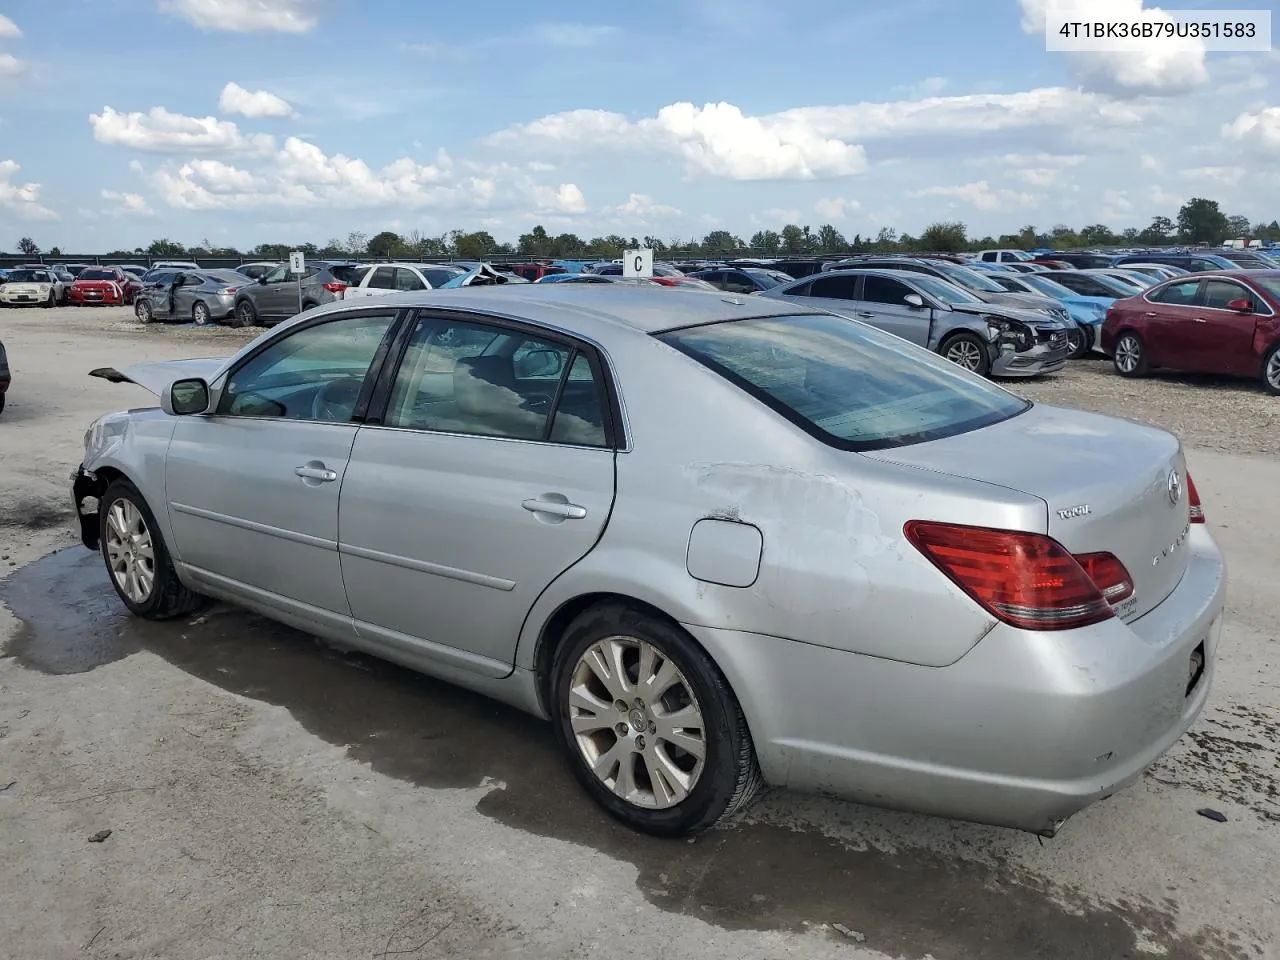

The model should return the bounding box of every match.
[568,636,707,810]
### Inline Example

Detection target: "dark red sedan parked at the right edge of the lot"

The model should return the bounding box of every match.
[1101,270,1280,396]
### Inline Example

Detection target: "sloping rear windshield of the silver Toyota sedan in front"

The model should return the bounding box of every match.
[659,314,1030,451]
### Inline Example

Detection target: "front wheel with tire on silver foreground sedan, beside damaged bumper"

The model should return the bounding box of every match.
[97,480,207,620]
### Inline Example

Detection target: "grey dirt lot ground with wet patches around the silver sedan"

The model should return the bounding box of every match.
[0,308,1280,960]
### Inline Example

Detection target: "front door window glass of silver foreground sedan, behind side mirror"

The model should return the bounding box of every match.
[218,312,396,424]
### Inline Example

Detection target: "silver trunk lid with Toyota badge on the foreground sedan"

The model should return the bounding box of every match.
[864,404,1190,621]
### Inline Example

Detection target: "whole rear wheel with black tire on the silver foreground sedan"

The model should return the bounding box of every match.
[550,603,762,837]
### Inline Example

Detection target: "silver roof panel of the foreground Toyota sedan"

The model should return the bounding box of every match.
[300,283,826,337]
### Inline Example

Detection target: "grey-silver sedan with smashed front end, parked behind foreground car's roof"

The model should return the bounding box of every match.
[756,269,1070,376]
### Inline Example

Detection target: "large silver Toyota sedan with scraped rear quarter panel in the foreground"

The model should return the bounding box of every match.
[73,284,1225,836]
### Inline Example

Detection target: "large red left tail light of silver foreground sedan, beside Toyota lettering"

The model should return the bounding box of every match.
[902,520,1133,630]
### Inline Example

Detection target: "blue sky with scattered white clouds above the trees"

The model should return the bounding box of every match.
[0,0,1280,252]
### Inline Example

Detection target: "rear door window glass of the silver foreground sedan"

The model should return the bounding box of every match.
[383,317,607,447]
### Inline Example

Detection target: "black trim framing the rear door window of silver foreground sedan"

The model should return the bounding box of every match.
[356,307,631,453]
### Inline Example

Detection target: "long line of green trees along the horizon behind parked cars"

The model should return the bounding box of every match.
[7,197,1280,260]
